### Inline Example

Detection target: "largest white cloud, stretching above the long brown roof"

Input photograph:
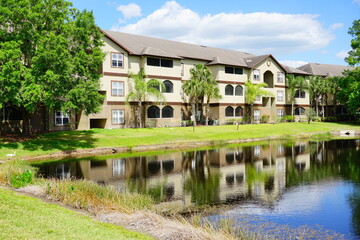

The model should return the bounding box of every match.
[112,1,334,55]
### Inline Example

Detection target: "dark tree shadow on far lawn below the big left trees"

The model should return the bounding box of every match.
[0,130,97,151]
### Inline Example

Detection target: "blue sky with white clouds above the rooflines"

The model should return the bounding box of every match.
[69,0,360,67]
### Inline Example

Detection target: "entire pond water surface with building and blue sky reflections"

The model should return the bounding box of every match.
[36,139,360,239]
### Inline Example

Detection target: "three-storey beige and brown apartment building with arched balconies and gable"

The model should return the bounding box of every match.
[77,30,309,129]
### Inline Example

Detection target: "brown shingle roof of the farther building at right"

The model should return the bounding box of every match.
[297,63,354,77]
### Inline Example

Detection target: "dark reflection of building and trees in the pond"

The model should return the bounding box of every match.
[39,141,360,206]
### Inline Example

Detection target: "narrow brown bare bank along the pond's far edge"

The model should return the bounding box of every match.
[21,130,360,162]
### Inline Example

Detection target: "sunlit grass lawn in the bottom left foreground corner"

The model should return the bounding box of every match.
[0,188,152,239]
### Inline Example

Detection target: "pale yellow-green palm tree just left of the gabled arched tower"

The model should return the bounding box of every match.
[245,80,273,123]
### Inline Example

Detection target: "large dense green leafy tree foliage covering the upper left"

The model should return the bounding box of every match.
[0,0,104,134]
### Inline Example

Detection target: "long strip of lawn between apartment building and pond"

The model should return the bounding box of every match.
[0,122,360,159]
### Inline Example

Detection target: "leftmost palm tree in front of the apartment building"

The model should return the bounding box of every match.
[126,68,165,128]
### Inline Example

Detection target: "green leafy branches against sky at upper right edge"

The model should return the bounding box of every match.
[345,19,360,66]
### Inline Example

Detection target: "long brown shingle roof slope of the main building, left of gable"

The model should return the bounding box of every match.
[102,30,261,68]
